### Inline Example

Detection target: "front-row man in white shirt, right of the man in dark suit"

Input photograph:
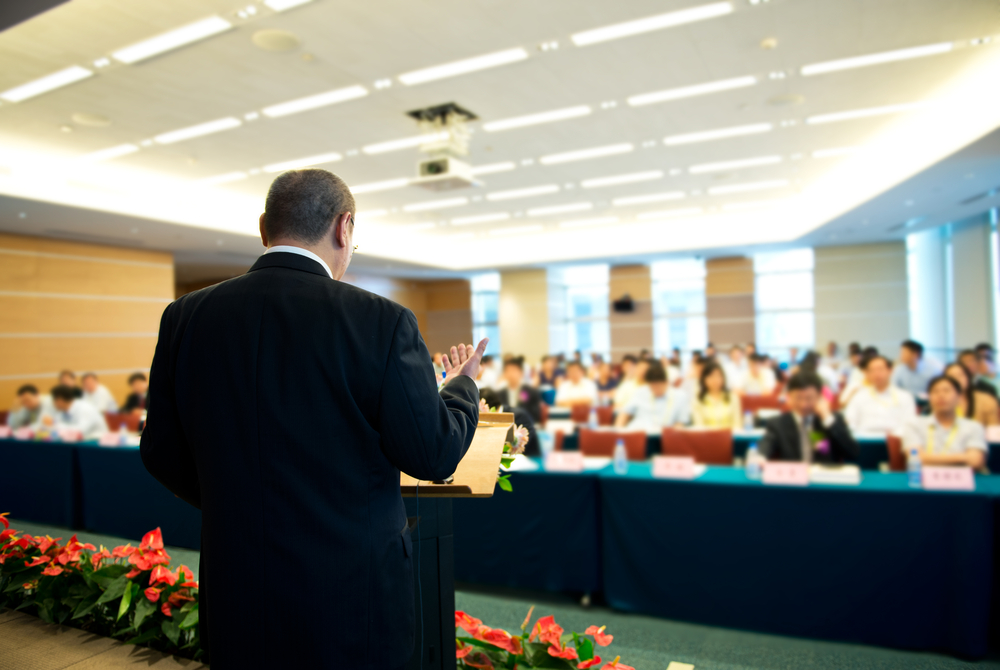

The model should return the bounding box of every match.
[903,376,987,472]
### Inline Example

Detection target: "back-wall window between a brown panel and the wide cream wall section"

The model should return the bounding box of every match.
[753,249,816,359]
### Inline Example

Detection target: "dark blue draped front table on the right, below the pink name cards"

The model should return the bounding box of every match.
[600,463,1000,656]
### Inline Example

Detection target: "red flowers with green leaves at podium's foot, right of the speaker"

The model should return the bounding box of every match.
[455,607,635,670]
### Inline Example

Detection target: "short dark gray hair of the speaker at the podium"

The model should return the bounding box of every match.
[264,168,355,244]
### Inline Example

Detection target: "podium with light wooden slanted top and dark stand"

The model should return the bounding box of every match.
[399,413,514,670]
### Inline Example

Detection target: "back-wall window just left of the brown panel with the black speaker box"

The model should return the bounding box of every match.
[548,265,611,359]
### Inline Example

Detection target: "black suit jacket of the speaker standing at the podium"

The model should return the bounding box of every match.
[142,253,479,670]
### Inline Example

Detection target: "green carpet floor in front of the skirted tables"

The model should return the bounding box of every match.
[11,519,1000,670]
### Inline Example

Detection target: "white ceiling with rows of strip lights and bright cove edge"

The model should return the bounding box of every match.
[0,0,1000,271]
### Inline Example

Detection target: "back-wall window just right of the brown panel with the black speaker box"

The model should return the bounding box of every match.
[650,258,708,356]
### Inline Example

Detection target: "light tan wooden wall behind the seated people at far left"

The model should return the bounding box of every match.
[0,234,174,407]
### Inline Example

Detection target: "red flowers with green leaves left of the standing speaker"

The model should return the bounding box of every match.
[0,512,202,659]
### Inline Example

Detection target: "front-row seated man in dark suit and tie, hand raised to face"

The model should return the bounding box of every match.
[760,372,858,463]
